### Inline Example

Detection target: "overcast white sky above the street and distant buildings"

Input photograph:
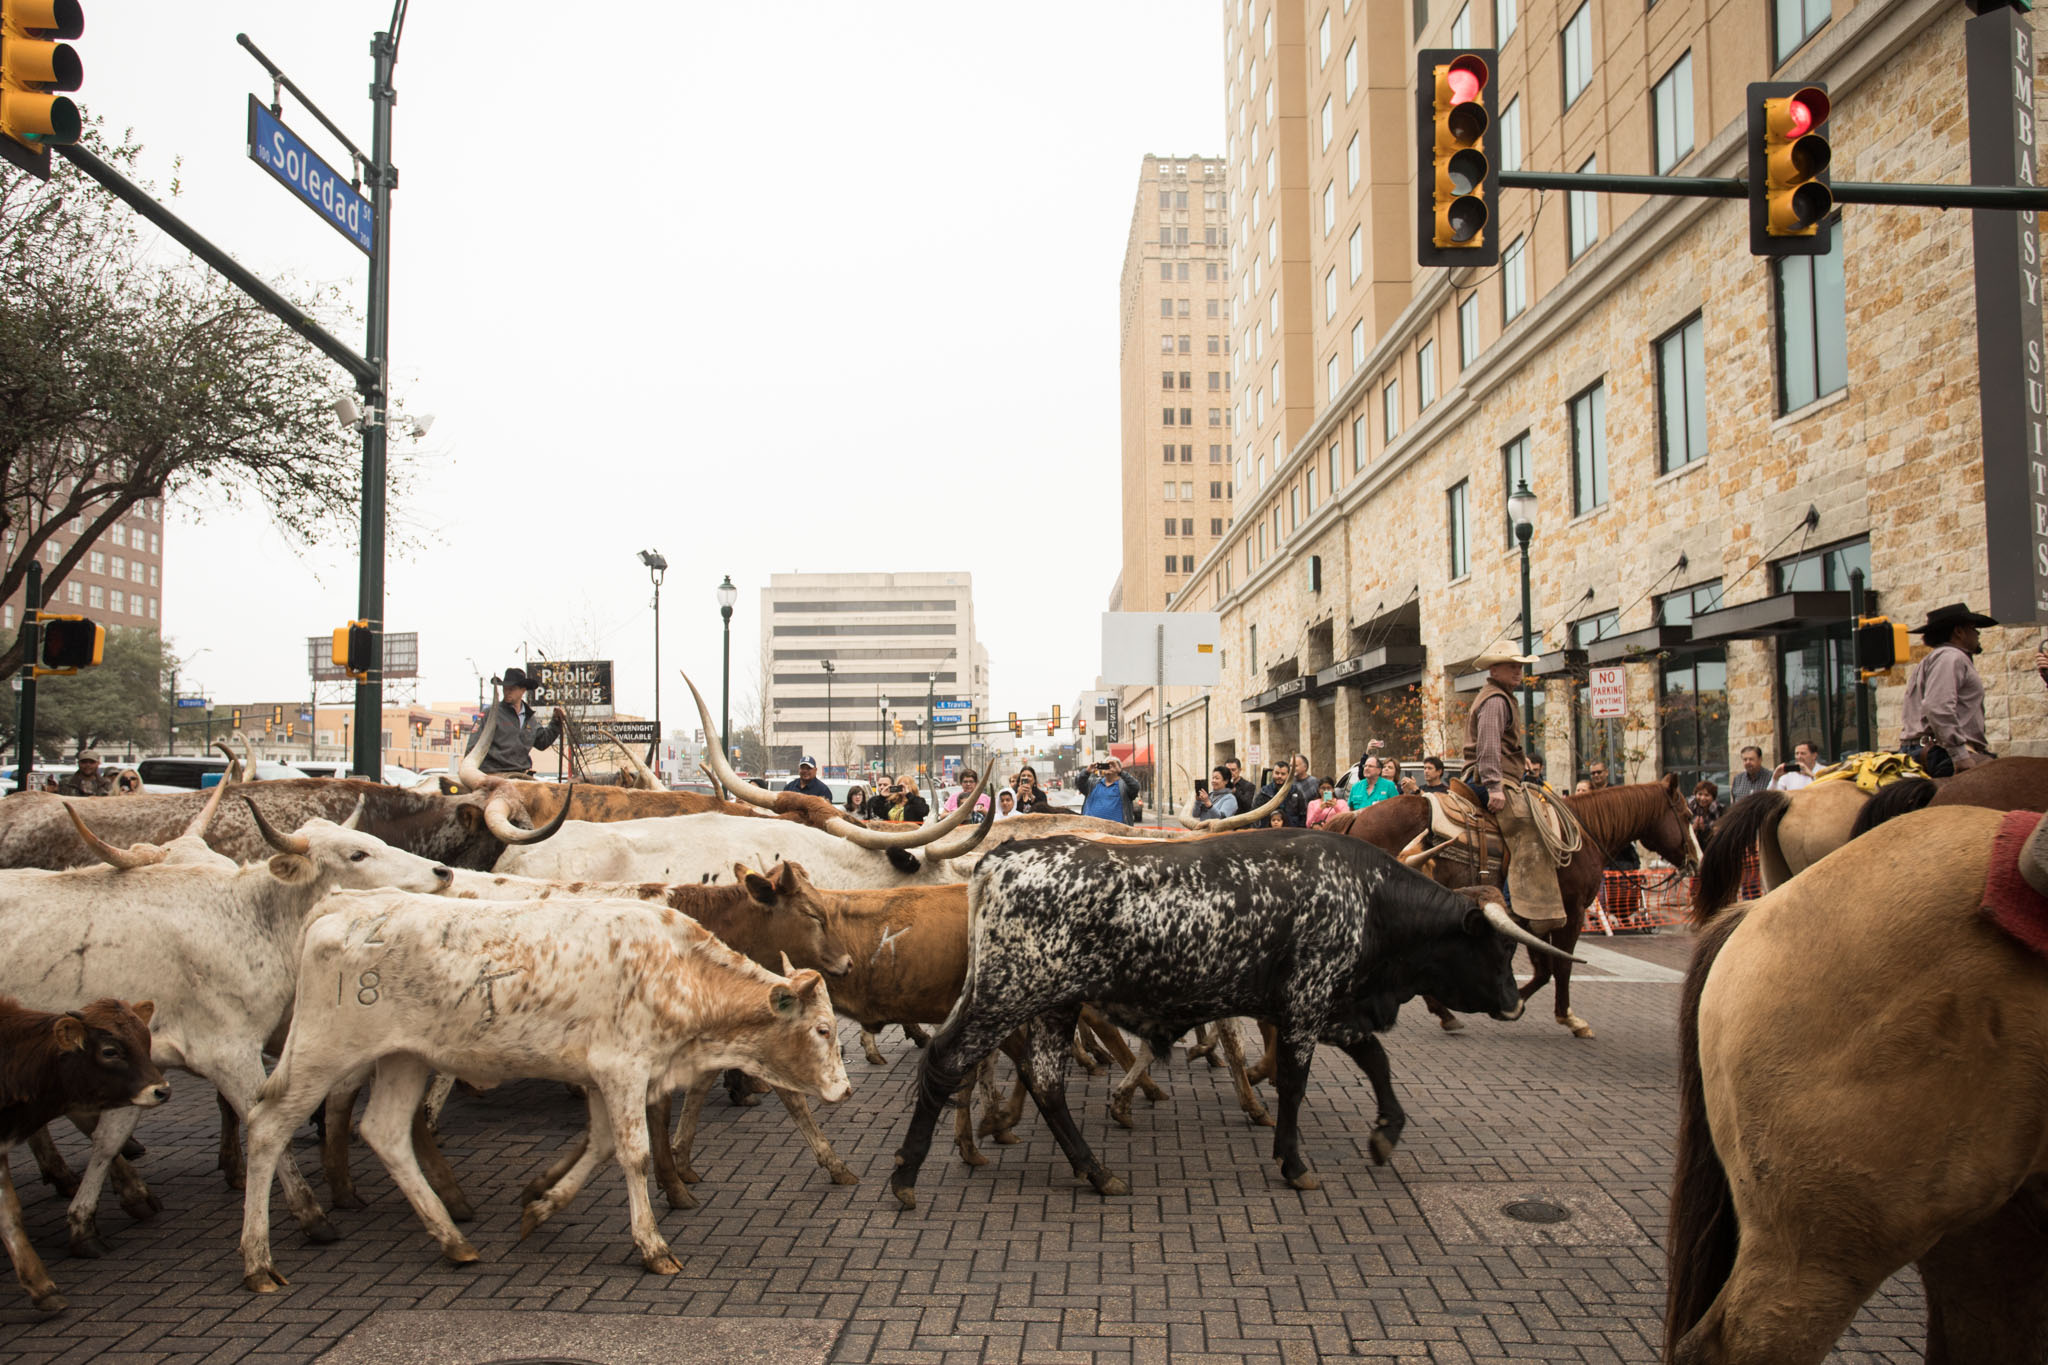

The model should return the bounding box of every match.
[78,0,1223,722]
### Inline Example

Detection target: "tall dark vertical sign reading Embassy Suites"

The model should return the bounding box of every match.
[1964,8,2048,624]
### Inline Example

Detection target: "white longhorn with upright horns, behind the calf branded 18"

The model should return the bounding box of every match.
[0,806,449,1257]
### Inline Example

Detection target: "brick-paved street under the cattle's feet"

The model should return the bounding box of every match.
[0,933,1919,1365]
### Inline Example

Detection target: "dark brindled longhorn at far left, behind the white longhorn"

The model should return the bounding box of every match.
[0,778,565,870]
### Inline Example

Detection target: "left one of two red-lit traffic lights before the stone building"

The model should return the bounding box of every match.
[1415,47,1501,266]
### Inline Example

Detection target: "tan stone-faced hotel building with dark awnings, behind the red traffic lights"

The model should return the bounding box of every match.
[1155,0,2048,786]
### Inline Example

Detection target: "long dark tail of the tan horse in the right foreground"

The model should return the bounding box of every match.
[1663,911,1747,1361]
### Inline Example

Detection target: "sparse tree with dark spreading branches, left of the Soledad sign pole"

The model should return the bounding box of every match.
[0,129,419,677]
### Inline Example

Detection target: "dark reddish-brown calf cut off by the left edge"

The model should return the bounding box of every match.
[0,997,170,1312]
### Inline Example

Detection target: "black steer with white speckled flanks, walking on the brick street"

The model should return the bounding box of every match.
[891,829,1565,1207]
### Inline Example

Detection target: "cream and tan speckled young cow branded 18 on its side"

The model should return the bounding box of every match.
[242,892,850,1293]
